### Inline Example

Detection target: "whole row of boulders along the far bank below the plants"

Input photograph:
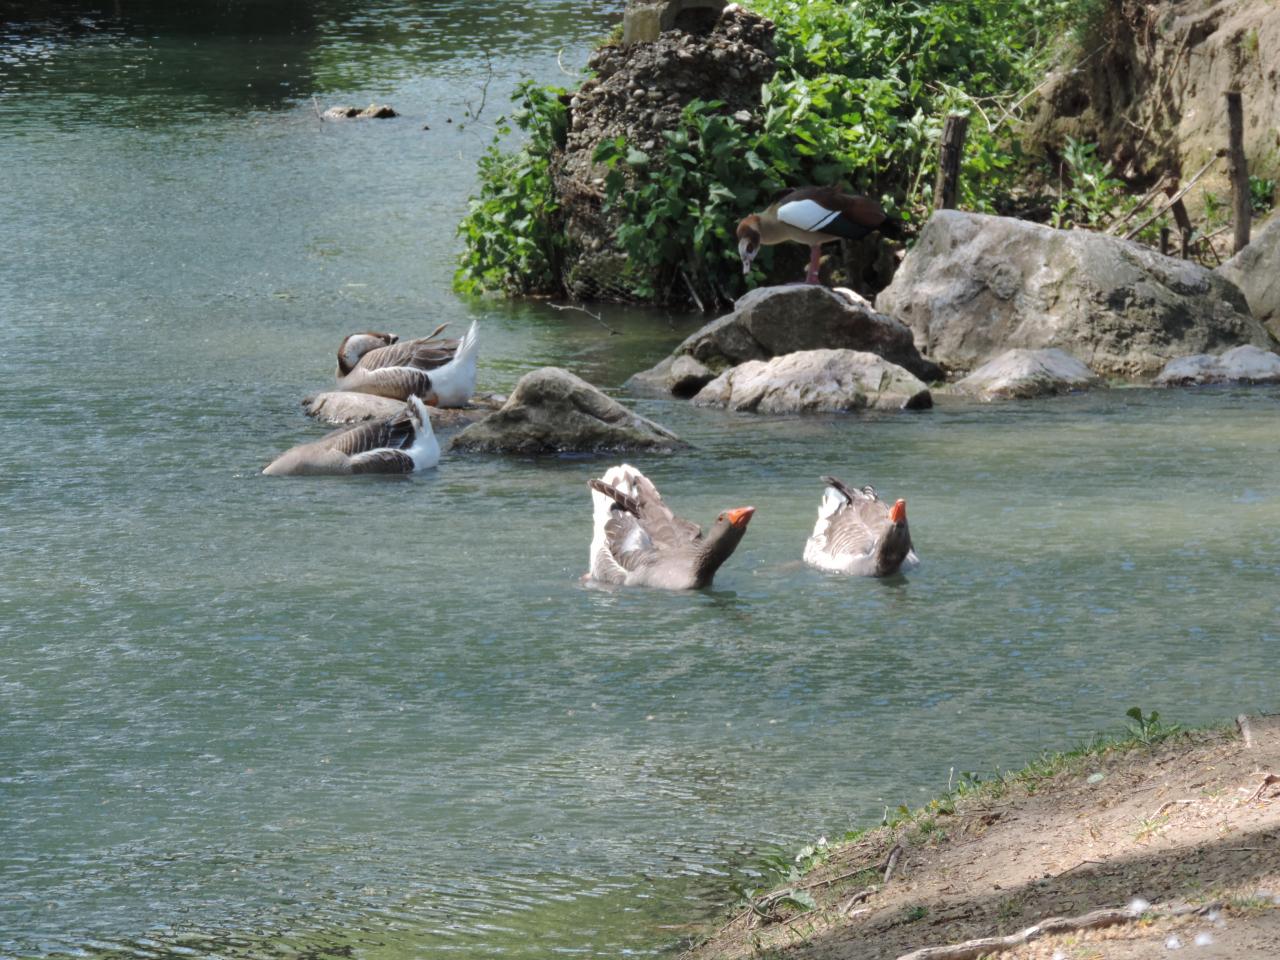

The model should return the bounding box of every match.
[627,210,1280,413]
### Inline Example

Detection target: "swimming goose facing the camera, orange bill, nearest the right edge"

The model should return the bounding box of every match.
[804,476,920,577]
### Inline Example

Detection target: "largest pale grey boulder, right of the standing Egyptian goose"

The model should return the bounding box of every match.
[877,210,1272,376]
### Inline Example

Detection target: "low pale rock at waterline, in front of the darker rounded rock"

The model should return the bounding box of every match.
[694,349,933,413]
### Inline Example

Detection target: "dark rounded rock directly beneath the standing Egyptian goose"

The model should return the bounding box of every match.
[626,284,942,397]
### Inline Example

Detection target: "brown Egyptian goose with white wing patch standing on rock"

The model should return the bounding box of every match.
[737,187,899,283]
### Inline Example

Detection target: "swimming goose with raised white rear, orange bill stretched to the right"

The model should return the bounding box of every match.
[586,463,755,590]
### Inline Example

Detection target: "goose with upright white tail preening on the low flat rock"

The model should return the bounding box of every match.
[338,323,479,407]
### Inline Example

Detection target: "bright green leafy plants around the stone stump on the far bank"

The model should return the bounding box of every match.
[457,0,1121,301]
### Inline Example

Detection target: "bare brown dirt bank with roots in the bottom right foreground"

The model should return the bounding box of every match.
[686,717,1280,960]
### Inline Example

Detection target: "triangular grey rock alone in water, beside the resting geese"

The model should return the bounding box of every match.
[451,366,686,453]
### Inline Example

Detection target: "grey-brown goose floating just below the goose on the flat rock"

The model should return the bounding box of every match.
[262,397,440,476]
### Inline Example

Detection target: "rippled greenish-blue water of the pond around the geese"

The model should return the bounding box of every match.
[0,0,1280,957]
